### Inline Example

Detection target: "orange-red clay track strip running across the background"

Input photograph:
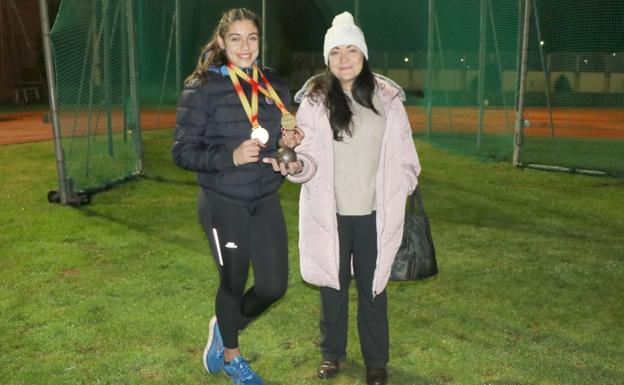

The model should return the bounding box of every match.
[0,107,624,145]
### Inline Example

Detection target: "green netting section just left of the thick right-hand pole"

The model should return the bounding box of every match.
[418,0,519,159]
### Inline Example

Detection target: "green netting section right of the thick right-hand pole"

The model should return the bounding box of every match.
[518,0,624,176]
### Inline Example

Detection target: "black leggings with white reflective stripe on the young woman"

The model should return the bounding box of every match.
[198,191,288,349]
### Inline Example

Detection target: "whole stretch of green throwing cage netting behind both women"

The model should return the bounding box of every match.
[40,0,624,204]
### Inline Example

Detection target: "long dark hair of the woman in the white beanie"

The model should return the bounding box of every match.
[310,58,379,141]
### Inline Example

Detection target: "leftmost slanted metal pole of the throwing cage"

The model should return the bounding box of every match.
[39,0,72,205]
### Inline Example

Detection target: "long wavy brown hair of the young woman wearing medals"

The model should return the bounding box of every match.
[184,8,262,84]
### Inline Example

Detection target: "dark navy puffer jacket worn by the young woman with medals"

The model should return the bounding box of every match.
[172,67,290,206]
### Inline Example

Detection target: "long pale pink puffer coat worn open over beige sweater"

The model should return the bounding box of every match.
[288,75,420,297]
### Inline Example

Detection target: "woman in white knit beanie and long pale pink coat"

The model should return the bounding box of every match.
[264,12,420,385]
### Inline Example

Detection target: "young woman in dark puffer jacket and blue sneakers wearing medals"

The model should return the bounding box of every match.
[172,8,301,385]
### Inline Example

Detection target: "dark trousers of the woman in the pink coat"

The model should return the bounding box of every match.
[320,211,389,368]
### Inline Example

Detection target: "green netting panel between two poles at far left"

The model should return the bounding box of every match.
[44,0,142,202]
